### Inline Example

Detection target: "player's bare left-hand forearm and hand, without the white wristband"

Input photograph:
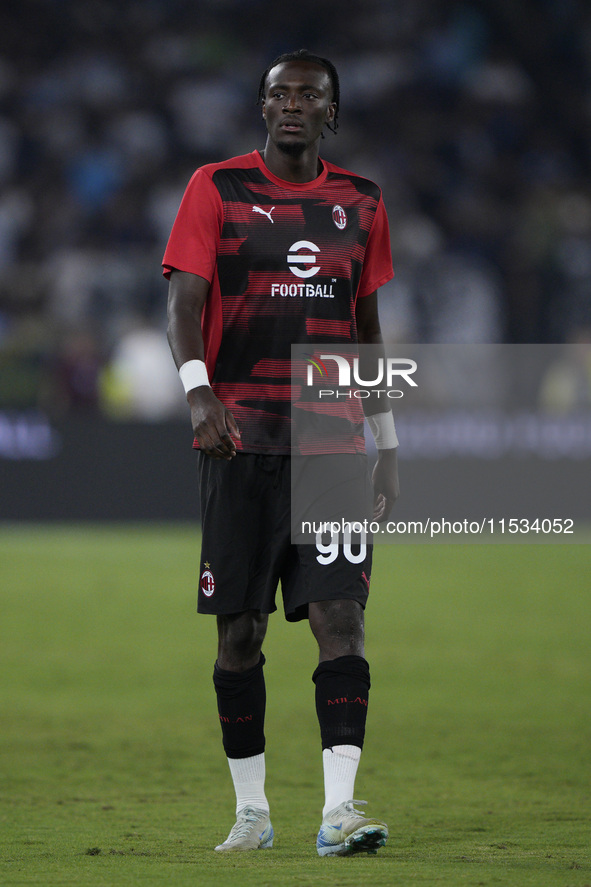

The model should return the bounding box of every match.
[168,270,240,459]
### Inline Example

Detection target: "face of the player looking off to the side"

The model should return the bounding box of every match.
[263,62,336,155]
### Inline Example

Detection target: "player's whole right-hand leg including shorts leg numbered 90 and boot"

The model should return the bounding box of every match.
[284,454,387,855]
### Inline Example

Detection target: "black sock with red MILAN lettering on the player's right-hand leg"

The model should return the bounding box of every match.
[312,656,370,749]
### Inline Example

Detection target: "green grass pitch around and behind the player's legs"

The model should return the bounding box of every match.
[0,525,591,887]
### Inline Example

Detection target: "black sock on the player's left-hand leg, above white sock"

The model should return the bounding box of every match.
[213,653,266,758]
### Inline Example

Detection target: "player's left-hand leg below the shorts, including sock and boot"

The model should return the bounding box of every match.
[213,610,273,850]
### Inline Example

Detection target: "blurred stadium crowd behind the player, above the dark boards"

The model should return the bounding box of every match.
[0,0,591,419]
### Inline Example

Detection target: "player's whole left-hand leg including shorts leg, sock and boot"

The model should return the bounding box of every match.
[198,453,290,850]
